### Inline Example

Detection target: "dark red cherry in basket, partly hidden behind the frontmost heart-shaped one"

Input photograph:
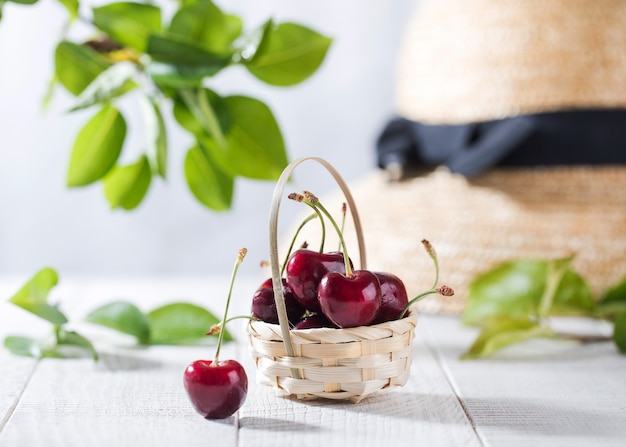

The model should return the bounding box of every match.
[285,249,346,312]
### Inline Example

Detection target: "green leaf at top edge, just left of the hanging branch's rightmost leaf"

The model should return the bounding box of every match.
[169,0,232,53]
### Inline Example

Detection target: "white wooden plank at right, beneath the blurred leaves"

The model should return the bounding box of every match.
[423,316,626,447]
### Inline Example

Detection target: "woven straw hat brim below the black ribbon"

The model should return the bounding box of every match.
[292,167,626,314]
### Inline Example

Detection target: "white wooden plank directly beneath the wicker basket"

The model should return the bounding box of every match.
[239,324,480,447]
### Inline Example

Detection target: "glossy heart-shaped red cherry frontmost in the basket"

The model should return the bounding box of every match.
[318,270,382,328]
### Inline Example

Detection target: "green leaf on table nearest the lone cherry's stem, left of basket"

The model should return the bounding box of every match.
[148,303,233,345]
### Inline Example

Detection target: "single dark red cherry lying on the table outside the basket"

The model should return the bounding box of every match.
[183,360,248,419]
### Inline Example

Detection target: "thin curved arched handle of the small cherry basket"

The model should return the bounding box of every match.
[269,157,366,368]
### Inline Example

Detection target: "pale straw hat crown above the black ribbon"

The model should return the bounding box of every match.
[396,0,626,124]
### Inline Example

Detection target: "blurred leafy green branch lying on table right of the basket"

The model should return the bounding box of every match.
[462,257,626,359]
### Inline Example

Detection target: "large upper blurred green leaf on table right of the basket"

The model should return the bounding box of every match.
[462,259,594,325]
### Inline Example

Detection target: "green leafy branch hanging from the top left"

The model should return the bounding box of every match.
[0,0,331,211]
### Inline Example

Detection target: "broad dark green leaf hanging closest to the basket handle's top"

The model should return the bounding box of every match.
[202,96,288,180]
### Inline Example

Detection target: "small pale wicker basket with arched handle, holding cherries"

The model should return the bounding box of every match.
[247,158,417,402]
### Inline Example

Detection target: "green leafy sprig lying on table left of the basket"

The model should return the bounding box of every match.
[4,267,233,360]
